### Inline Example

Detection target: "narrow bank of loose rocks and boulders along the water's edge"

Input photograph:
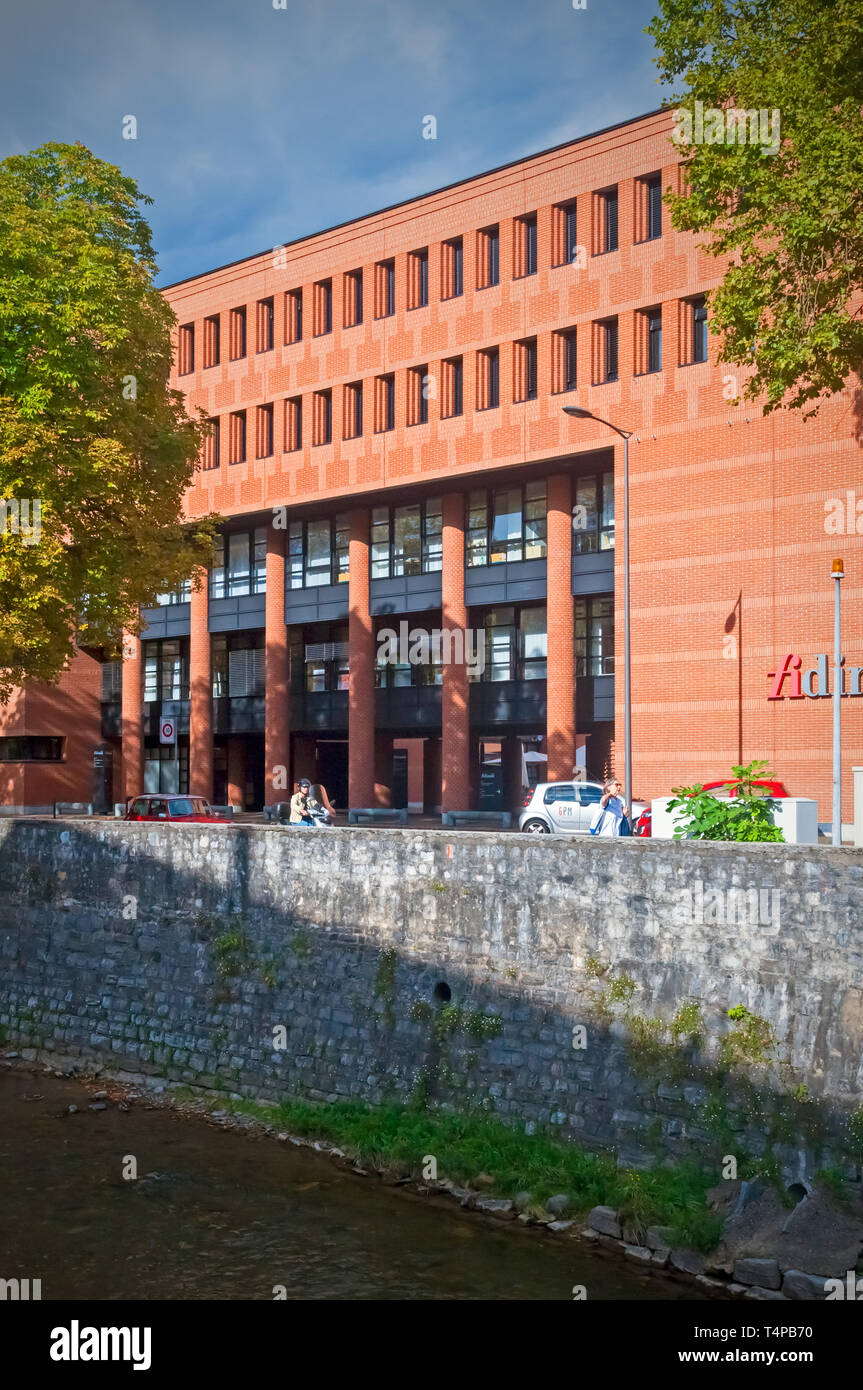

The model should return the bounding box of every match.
[0,1049,863,1301]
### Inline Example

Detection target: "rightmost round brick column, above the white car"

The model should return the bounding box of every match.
[546,474,575,781]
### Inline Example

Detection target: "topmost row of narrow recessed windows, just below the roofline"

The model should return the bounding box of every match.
[178,174,661,375]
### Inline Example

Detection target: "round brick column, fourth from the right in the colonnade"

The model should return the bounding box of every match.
[264,525,292,806]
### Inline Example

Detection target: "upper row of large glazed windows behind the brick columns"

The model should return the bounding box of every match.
[158,468,614,605]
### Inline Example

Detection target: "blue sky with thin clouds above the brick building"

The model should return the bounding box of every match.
[0,0,663,284]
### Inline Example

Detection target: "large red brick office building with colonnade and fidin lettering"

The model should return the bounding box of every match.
[0,113,863,819]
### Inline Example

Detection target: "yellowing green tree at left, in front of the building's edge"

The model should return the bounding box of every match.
[0,145,213,699]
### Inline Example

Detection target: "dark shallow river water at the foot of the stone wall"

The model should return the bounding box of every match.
[0,1068,696,1300]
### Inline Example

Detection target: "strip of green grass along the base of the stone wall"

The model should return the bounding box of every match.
[220,1099,720,1250]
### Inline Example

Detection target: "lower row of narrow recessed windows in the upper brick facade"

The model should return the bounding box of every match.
[202,296,707,468]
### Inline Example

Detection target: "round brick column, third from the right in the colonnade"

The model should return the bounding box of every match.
[347,509,375,809]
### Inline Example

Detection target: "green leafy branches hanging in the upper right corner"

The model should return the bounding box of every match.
[646,0,863,416]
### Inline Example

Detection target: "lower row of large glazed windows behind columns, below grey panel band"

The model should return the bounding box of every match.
[131,595,614,706]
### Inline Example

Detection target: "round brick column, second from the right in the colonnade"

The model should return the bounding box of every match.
[441,492,471,810]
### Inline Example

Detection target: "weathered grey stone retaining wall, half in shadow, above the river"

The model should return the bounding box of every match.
[0,820,863,1176]
